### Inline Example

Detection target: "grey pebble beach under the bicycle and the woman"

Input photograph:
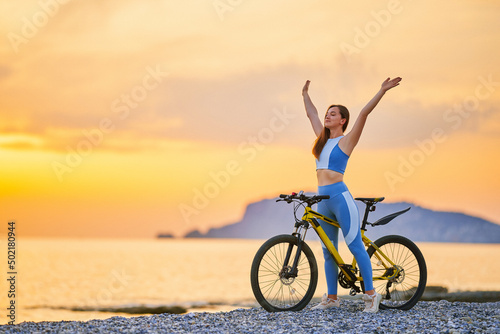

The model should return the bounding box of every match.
[0,300,500,334]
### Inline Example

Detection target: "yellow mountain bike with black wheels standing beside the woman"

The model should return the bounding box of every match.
[250,191,427,312]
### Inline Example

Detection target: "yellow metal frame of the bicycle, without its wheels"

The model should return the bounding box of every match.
[302,206,400,281]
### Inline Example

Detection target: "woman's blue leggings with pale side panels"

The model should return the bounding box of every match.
[318,182,373,295]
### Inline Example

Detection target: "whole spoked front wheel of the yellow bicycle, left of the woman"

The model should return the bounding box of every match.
[250,234,318,312]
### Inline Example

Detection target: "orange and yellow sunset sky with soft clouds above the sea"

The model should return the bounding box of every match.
[0,0,500,237]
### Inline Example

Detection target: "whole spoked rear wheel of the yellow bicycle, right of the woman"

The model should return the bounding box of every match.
[361,235,427,310]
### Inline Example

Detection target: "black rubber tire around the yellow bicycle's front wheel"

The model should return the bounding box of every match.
[250,234,318,312]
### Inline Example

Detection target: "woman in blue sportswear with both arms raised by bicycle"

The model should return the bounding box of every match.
[302,77,401,313]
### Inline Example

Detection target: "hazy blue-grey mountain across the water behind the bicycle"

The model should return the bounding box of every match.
[185,199,500,243]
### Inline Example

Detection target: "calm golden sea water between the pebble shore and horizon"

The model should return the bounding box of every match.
[0,239,500,324]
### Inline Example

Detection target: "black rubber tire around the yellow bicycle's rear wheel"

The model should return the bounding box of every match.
[361,235,427,310]
